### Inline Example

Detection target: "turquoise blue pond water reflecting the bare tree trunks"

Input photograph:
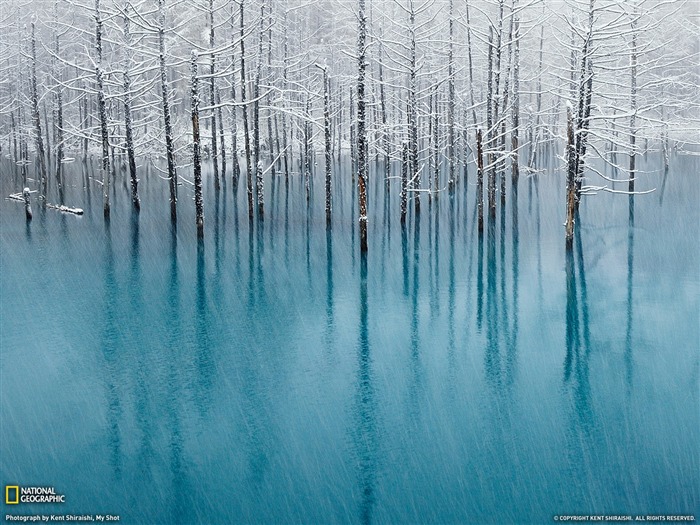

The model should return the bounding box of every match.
[0,156,700,523]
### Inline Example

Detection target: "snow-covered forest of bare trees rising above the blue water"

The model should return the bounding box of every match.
[0,0,700,241]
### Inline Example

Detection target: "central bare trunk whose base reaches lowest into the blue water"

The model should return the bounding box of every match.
[357,0,368,254]
